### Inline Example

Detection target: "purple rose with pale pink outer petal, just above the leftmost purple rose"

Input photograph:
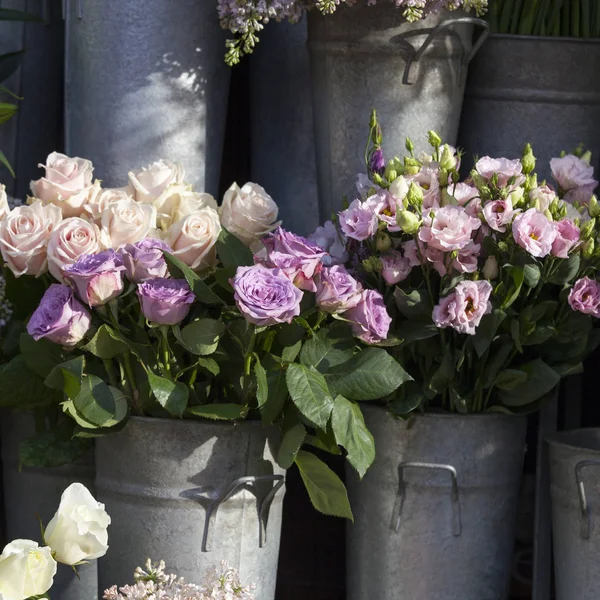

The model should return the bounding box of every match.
[63,250,125,306]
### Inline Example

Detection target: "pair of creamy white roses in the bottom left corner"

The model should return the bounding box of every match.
[0,483,110,600]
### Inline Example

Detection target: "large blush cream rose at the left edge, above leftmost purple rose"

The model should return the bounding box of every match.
[0,200,61,277]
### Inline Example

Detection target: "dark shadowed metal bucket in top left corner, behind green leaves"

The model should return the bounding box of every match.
[0,0,64,200]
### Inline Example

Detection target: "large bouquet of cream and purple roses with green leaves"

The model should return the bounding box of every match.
[0,155,408,517]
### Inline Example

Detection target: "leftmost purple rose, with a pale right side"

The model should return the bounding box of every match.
[27,283,90,348]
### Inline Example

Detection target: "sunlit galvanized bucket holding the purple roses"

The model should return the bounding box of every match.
[96,417,285,600]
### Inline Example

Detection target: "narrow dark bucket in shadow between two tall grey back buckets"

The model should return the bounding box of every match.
[250,20,319,235]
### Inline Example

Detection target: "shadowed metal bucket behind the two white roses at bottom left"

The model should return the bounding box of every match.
[0,411,98,600]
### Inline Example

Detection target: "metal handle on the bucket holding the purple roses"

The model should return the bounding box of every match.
[185,475,285,552]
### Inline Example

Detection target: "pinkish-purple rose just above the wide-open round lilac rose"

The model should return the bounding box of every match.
[259,227,327,292]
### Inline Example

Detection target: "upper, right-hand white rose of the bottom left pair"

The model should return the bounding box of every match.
[44,483,110,565]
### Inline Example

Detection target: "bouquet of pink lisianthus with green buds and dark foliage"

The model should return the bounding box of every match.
[328,113,600,414]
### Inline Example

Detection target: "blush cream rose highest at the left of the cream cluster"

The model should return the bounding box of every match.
[31,152,99,217]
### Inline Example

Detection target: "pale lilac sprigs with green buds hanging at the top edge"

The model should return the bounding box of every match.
[217,0,488,65]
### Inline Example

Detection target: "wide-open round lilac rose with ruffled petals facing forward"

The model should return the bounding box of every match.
[231,265,304,326]
